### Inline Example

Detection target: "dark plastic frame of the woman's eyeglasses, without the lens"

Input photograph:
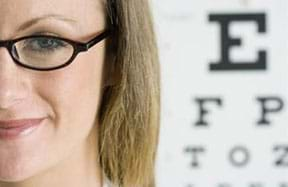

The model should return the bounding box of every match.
[0,29,112,71]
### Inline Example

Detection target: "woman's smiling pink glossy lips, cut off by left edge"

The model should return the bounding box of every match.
[0,118,45,140]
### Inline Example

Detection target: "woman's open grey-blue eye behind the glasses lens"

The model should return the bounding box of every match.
[22,37,68,52]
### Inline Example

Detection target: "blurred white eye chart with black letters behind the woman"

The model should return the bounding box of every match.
[151,0,288,187]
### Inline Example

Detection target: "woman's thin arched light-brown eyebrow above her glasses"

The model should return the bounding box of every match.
[17,14,76,32]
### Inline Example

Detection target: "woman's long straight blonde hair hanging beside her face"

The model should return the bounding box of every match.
[99,0,160,187]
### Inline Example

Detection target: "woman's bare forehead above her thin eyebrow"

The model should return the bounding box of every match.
[0,0,104,36]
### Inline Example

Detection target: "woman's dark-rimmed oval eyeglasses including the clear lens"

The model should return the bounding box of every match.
[0,30,112,71]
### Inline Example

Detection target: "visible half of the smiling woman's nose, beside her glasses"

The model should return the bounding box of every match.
[0,47,27,110]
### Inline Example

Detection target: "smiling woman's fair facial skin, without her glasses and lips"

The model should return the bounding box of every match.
[0,0,105,181]
